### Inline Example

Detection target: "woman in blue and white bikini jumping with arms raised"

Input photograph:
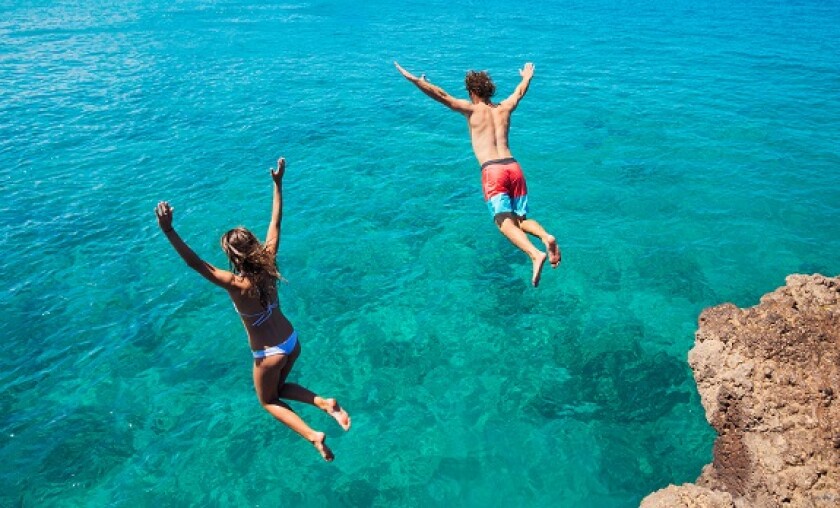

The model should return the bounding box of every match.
[155,157,350,462]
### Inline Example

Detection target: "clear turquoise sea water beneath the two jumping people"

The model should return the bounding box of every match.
[0,0,840,506]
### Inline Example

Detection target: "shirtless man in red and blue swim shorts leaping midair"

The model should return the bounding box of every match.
[394,62,560,287]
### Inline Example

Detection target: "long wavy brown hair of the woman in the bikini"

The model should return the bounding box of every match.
[222,227,281,308]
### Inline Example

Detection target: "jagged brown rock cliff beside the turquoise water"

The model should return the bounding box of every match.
[642,275,840,508]
